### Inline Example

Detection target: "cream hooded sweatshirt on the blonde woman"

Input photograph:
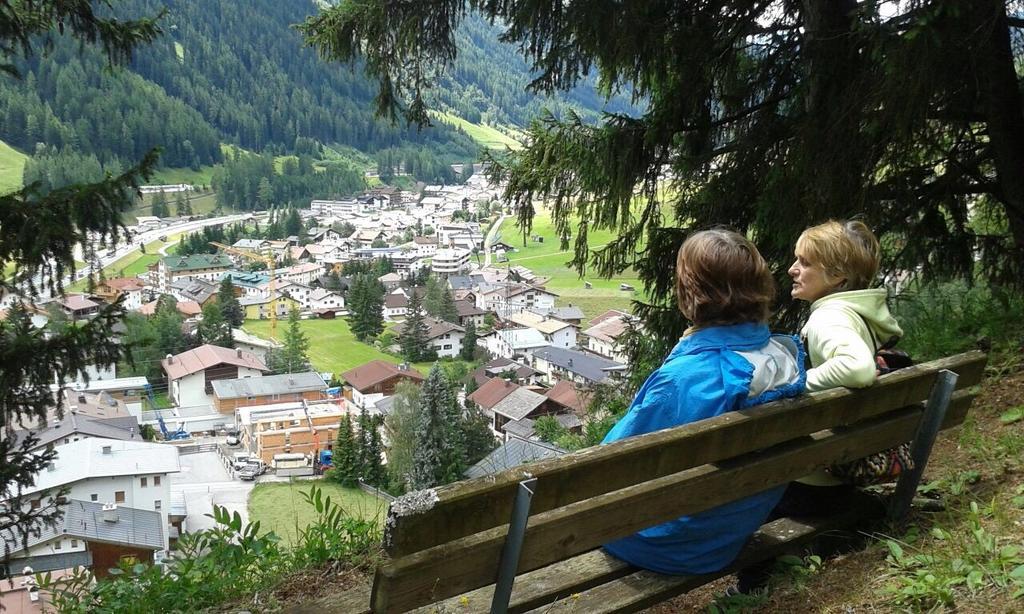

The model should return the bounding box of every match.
[798,288,903,486]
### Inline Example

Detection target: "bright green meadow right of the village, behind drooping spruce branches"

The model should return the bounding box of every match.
[501,211,641,319]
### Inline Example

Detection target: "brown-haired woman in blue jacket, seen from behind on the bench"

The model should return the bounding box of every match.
[604,229,805,574]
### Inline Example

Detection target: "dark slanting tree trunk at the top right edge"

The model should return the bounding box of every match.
[968,0,1024,271]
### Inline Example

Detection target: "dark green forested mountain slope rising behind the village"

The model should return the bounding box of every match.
[0,0,626,179]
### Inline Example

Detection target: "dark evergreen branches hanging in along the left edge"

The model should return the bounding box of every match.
[0,0,160,557]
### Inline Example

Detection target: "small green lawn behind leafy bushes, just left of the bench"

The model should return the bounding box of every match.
[249,480,387,545]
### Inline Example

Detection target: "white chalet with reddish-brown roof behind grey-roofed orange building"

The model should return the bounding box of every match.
[160,344,270,406]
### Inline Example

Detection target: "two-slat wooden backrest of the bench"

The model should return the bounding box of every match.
[372,352,986,612]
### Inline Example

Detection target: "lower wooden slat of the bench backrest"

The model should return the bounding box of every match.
[373,404,922,612]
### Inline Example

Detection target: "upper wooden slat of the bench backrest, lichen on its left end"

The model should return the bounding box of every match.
[384,351,987,558]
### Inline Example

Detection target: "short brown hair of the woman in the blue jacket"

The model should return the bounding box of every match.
[676,228,775,326]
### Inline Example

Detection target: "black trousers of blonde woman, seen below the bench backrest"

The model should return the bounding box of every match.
[736,482,883,593]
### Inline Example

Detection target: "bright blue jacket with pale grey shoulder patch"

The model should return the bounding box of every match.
[604,323,807,574]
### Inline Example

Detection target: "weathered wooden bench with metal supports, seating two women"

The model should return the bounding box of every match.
[325,352,986,613]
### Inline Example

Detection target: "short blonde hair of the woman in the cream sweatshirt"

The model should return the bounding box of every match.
[797,220,882,290]
